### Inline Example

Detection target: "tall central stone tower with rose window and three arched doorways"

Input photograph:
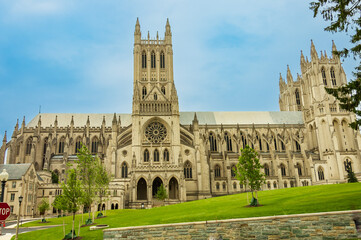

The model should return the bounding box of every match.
[131,19,186,207]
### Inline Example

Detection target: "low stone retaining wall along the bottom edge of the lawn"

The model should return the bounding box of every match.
[103,210,361,240]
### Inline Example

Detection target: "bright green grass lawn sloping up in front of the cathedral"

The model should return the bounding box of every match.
[14,183,361,240]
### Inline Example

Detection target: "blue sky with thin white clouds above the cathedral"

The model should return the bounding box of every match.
[0,0,355,140]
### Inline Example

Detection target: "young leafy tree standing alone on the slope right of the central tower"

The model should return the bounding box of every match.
[236,145,266,206]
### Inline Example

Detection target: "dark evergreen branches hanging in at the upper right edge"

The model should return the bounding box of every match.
[310,0,361,130]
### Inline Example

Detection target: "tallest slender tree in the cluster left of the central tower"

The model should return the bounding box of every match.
[75,144,98,224]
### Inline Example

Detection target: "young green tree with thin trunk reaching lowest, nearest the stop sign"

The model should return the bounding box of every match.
[57,169,84,238]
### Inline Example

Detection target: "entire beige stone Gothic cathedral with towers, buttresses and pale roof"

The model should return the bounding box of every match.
[0,20,361,212]
